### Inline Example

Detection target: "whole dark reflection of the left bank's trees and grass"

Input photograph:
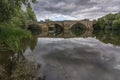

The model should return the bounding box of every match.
[0,38,42,80]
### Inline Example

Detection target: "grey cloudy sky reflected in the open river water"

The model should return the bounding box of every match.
[33,37,120,80]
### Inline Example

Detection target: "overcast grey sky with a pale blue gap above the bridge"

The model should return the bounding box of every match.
[33,0,120,20]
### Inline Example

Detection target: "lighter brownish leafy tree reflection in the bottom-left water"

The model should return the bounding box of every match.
[11,53,38,80]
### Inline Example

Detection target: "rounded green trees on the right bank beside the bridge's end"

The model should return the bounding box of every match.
[94,12,120,30]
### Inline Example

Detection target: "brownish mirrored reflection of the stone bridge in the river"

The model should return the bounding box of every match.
[38,30,92,38]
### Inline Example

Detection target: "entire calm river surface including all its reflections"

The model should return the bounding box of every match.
[0,31,120,80]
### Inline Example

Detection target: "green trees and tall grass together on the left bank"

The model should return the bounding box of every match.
[0,0,36,52]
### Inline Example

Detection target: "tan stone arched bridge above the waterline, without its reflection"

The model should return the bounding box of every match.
[38,20,94,30]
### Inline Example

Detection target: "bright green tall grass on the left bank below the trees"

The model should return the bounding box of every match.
[0,25,31,52]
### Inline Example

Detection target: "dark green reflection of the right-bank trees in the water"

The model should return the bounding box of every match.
[94,30,120,45]
